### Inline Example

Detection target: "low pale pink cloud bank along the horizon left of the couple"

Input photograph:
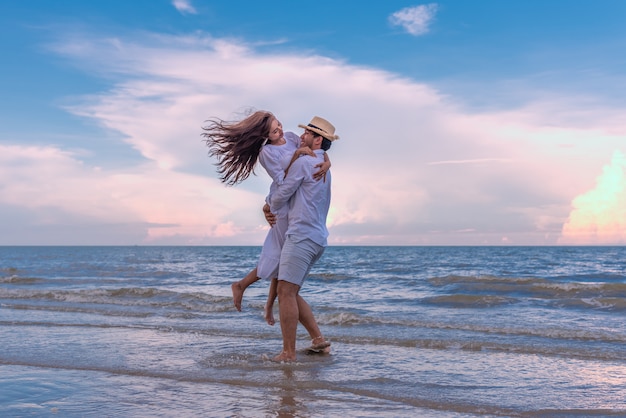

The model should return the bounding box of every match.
[0,145,266,245]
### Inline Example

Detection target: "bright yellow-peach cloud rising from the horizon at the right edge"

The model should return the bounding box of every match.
[559,150,626,244]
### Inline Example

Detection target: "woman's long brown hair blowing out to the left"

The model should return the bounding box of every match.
[202,110,274,186]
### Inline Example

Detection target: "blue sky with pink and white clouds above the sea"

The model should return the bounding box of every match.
[0,0,626,245]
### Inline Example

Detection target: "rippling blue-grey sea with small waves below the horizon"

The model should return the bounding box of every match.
[0,246,626,418]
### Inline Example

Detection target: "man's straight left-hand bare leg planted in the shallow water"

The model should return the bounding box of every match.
[274,280,300,361]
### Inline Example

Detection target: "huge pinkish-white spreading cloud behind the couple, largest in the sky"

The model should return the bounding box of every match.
[0,34,626,245]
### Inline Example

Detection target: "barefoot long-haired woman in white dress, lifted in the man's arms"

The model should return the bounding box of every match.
[202,111,330,347]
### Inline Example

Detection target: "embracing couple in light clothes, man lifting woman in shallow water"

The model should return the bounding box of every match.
[203,111,339,362]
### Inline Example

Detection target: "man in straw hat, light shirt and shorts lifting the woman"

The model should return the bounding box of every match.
[269,116,339,362]
